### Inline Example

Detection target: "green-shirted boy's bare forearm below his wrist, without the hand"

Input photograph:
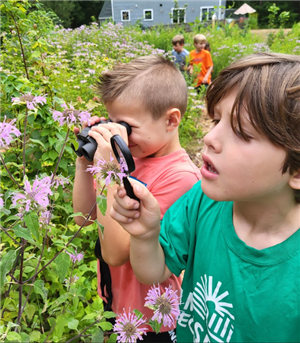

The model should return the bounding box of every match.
[130,236,172,285]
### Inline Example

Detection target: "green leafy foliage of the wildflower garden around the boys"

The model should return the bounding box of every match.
[0,0,300,342]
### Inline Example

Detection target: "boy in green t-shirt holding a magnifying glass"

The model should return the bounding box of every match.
[111,53,300,342]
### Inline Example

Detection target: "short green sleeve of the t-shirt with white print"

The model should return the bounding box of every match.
[159,182,203,276]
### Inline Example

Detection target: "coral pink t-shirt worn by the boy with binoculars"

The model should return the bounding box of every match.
[97,149,201,331]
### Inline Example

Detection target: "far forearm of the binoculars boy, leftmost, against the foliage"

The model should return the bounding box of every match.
[73,158,96,225]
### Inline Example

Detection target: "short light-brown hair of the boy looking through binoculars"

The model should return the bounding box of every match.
[96,55,187,120]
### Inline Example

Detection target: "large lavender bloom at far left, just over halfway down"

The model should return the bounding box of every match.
[12,176,52,212]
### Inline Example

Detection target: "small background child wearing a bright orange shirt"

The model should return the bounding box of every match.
[188,34,213,93]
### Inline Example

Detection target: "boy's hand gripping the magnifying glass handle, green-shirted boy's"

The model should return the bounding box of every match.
[110,180,160,239]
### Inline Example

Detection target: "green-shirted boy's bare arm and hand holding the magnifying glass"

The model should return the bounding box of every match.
[110,180,172,284]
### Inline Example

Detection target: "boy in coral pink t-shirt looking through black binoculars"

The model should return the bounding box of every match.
[73,55,201,342]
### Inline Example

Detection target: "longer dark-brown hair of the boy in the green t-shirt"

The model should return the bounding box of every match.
[206,53,300,202]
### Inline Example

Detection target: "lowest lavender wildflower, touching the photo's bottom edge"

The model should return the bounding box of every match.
[113,310,148,343]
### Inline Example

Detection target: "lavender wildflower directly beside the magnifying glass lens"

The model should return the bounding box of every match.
[86,155,127,186]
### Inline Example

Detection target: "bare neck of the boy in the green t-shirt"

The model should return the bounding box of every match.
[233,198,300,250]
